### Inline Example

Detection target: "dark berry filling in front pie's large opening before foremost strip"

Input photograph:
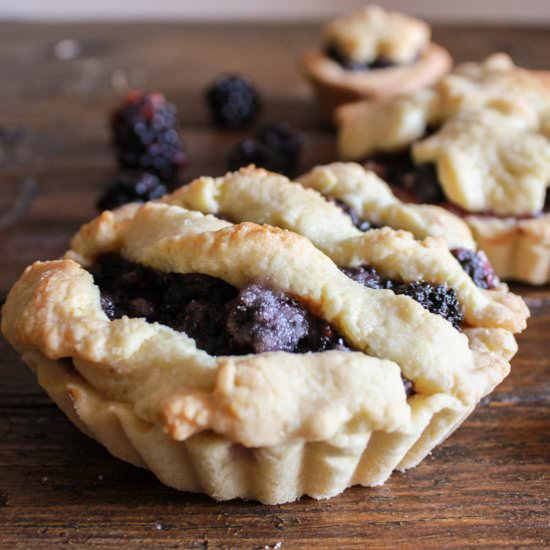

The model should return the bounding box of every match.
[90,254,348,355]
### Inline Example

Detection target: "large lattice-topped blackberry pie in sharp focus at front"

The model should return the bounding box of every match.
[2,168,528,503]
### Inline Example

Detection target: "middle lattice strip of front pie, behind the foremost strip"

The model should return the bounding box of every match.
[169,168,527,331]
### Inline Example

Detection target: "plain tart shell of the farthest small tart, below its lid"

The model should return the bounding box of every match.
[302,42,452,123]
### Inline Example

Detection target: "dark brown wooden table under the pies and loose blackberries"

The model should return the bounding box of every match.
[0,23,550,549]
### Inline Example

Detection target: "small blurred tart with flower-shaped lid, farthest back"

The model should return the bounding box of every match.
[302,6,452,120]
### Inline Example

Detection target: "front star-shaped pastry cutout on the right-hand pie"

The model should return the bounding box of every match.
[413,109,550,215]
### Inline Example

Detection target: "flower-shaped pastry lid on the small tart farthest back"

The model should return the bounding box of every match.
[323,5,431,63]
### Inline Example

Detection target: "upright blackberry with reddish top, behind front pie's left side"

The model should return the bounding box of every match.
[111,91,187,182]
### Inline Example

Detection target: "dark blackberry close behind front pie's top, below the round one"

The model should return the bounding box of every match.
[227,122,303,177]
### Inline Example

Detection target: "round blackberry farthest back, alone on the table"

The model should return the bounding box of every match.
[206,74,260,130]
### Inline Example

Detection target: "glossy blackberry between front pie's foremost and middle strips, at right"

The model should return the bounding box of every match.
[393,282,464,329]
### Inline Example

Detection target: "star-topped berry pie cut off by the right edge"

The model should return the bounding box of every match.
[338,54,550,284]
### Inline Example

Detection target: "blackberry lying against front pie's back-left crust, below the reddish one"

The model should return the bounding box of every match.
[96,172,167,211]
